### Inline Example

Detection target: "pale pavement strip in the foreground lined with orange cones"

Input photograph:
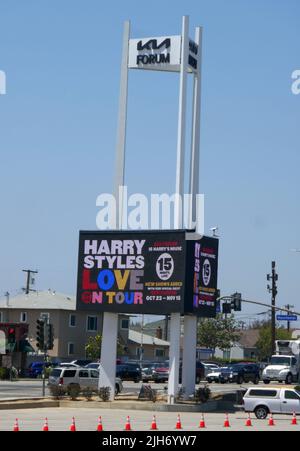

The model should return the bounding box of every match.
[0,408,300,434]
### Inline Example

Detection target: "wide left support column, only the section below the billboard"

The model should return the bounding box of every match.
[98,312,118,401]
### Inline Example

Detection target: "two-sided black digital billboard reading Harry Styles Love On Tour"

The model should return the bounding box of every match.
[77,231,218,317]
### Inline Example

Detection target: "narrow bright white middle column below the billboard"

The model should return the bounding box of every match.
[168,313,180,404]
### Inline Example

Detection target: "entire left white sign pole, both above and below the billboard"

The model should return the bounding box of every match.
[99,21,130,400]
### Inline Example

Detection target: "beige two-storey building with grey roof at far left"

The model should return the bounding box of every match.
[0,290,105,361]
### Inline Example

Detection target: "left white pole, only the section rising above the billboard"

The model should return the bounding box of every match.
[114,21,130,229]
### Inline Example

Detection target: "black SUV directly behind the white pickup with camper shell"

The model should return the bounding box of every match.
[219,363,260,384]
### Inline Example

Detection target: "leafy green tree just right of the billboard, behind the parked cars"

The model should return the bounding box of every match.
[197,315,240,351]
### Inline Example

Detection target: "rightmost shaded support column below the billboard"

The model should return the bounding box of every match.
[182,315,197,396]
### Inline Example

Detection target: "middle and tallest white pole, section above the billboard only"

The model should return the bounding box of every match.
[174,16,189,229]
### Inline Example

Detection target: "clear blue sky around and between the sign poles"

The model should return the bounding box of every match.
[0,0,300,324]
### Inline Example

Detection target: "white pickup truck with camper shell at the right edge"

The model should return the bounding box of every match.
[243,387,300,420]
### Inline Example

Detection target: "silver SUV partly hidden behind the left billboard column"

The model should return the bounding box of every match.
[48,367,123,394]
